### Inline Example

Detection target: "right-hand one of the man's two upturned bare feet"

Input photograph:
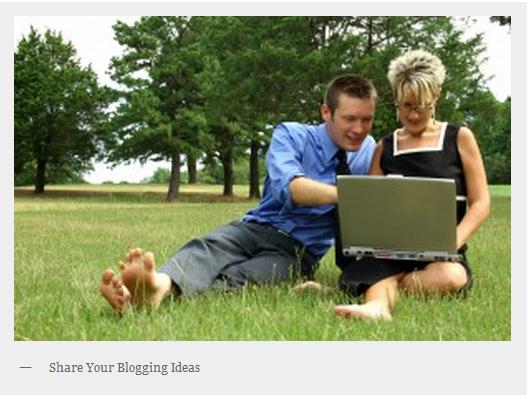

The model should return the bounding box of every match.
[119,248,172,307]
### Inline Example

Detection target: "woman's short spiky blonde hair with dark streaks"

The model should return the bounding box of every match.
[387,49,445,104]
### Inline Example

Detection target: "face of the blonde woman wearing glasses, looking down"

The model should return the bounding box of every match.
[396,92,436,134]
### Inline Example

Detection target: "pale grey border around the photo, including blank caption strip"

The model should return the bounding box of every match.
[4,2,527,395]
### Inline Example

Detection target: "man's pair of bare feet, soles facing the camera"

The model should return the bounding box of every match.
[100,248,172,314]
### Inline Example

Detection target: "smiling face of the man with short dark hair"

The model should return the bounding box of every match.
[321,94,376,151]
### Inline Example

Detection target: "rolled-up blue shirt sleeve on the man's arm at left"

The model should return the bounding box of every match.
[266,124,305,210]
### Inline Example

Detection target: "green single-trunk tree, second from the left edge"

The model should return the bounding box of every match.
[109,17,205,201]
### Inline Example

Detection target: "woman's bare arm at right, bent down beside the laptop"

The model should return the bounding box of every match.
[457,127,490,248]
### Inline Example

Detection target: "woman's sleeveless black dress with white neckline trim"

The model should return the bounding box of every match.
[339,123,471,296]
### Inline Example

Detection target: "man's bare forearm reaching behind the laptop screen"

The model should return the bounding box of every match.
[290,176,337,206]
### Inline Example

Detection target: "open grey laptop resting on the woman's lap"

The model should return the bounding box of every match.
[337,175,462,262]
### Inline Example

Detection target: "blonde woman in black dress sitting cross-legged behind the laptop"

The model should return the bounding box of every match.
[335,50,490,320]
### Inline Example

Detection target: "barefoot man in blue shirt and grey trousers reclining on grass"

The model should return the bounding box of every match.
[100,75,376,313]
